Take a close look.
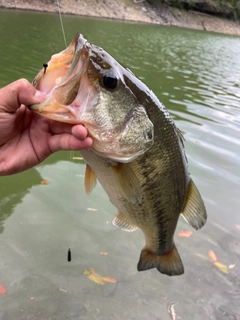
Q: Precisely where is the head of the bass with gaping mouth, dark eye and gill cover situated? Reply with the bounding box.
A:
[29,34,154,162]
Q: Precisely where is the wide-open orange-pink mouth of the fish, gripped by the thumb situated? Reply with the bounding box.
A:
[28,34,93,124]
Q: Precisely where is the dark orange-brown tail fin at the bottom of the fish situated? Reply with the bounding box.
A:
[137,244,184,276]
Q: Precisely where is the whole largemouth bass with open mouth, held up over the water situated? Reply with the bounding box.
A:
[29,34,207,276]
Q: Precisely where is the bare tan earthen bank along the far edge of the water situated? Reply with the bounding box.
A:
[0,0,240,36]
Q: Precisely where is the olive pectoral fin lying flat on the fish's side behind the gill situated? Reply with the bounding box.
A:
[112,163,142,203]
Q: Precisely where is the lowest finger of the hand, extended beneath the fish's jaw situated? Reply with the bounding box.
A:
[49,133,93,153]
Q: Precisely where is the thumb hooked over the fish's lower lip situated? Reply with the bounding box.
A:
[0,79,46,112]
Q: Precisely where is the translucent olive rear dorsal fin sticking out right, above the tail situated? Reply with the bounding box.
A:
[181,180,207,230]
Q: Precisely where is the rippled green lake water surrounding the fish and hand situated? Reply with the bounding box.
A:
[0,9,240,320]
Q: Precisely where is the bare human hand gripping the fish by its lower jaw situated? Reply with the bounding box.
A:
[0,79,92,176]
